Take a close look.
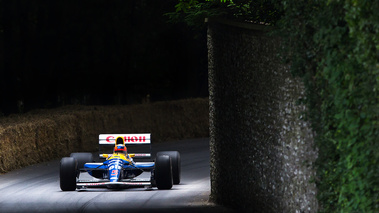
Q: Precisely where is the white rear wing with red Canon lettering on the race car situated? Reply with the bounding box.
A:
[99,133,151,159]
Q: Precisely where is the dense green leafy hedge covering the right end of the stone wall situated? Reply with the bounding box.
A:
[278,0,379,212]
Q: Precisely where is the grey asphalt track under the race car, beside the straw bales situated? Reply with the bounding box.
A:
[0,138,235,213]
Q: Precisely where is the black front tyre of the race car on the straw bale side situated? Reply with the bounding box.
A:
[59,157,78,191]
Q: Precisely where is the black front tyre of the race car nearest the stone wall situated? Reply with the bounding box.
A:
[154,155,173,189]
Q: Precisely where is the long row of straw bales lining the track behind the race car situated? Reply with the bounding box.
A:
[0,98,209,173]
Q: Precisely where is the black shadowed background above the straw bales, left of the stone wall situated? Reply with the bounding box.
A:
[0,0,208,115]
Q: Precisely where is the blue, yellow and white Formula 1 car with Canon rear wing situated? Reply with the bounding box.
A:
[60,134,181,191]
